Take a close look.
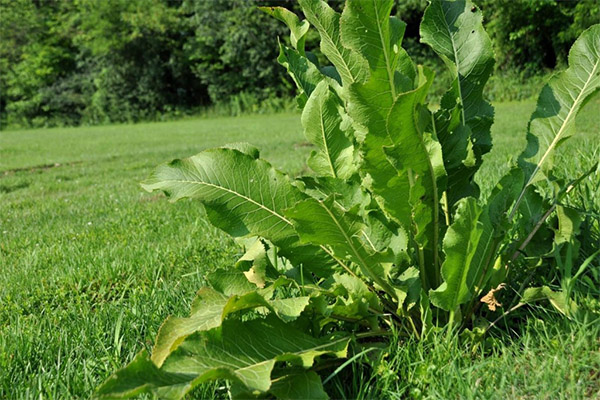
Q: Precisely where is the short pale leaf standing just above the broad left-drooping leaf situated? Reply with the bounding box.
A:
[302,81,356,178]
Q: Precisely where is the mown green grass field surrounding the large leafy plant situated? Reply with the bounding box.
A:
[0,98,600,399]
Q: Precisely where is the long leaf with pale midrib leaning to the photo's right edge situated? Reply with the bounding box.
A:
[514,24,600,210]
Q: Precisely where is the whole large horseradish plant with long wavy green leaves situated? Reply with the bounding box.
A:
[96,0,600,399]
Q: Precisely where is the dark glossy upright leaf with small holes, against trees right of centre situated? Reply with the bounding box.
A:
[421,0,494,208]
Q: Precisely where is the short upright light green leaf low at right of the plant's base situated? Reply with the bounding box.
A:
[429,197,484,311]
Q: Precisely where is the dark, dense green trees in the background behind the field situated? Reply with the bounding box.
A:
[0,0,599,126]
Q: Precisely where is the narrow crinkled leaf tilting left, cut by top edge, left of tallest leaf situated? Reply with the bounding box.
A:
[299,0,368,86]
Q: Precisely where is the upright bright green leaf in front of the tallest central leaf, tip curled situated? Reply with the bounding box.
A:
[382,67,446,288]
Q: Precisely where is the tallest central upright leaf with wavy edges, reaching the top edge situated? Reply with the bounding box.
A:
[341,0,415,229]
